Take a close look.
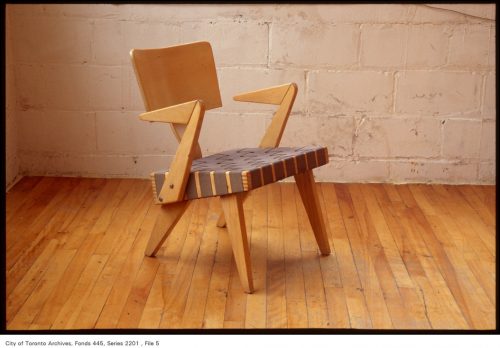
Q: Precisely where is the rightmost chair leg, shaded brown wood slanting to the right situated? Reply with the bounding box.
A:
[295,170,331,255]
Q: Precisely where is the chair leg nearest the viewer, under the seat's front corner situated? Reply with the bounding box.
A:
[221,193,254,293]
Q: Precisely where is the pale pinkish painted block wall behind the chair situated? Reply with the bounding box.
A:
[4,4,496,183]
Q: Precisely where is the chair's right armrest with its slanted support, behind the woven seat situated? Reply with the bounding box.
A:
[233,82,297,147]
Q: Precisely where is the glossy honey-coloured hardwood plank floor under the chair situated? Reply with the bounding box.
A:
[6,177,496,330]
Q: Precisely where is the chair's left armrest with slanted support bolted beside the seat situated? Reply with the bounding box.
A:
[139,100,205,204]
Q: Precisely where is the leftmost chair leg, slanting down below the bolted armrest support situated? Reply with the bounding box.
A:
[145,201,189,256]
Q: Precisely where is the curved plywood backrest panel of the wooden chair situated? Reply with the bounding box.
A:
[130,42,222,111]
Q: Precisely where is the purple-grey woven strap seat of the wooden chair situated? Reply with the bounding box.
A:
[151,146,328,200]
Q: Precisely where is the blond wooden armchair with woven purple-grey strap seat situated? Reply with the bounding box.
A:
[130,42,330,293]
